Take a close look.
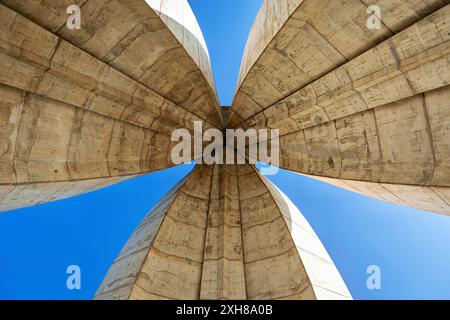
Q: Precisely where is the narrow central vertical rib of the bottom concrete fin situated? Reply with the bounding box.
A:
[200,165,246,300]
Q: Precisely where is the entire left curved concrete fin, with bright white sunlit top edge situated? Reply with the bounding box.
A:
[0,0,222,210]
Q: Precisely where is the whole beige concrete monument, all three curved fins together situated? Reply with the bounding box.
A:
[0,0,450,299]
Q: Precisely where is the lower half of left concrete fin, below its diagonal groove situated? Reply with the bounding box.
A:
[0,1,224,210]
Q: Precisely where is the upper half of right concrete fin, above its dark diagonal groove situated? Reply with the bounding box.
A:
[231,0,448,126]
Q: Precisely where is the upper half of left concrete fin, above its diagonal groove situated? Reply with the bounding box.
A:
[0,0,223,127]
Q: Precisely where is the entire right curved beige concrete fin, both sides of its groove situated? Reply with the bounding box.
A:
[230,0,450,214]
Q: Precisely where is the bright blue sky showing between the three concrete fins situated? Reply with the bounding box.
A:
[0,0,450,299]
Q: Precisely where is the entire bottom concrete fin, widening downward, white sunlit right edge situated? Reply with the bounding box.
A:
[96,165,351,300]
